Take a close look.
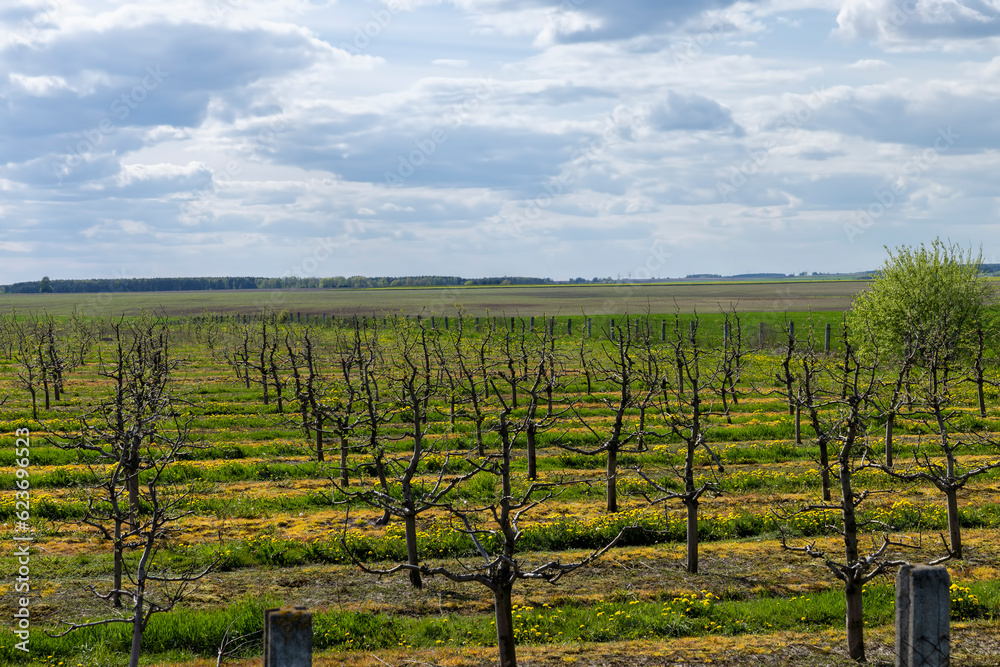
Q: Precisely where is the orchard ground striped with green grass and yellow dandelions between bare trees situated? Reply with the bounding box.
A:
[0,314,1000,667]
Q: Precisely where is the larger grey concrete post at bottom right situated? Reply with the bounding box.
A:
[896,565,951,667]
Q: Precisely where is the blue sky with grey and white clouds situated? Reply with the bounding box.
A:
[0,0,1000,283]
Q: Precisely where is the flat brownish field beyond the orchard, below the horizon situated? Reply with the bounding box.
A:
[0,280,868,317]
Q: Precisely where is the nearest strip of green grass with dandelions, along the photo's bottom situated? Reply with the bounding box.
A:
[0,581,1000,667]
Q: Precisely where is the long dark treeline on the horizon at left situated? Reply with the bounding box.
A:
[0,276,553,294]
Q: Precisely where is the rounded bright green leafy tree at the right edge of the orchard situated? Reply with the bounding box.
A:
[848,239,993,359]
